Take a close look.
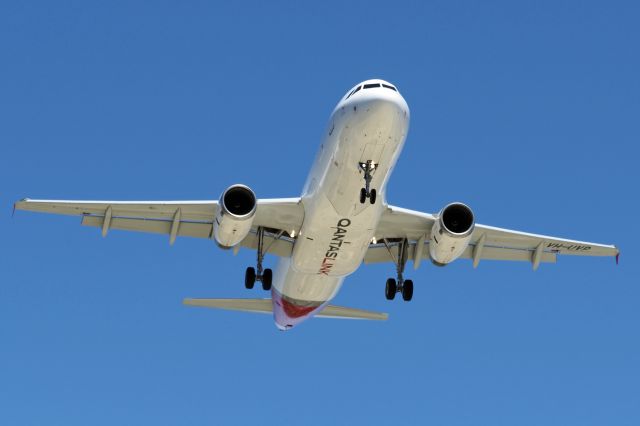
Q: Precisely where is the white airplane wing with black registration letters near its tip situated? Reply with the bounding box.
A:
[364,206,620,269]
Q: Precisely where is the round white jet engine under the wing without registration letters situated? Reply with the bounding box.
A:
[213,185,257,247]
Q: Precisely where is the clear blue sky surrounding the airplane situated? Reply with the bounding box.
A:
[0,1,640,425]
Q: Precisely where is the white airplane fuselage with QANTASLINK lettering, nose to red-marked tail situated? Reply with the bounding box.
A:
[272,80,409,330]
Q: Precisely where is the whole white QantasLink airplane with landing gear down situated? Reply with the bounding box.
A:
[14,79,619,330]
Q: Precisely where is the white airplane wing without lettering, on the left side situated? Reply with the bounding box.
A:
[14,198,304,256]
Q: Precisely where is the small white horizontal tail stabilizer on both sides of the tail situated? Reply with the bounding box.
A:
[183,299,388,320]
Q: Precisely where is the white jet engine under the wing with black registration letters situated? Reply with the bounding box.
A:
[429,203,475,266]
